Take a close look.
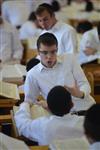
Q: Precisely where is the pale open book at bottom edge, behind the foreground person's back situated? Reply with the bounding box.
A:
[49,137,89,150]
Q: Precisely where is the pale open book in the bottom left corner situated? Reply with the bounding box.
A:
[0,132,29,150]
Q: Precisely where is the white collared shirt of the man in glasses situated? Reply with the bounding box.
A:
[24,54,93,110]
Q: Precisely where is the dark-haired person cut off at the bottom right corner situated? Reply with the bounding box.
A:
[84,104,100,150]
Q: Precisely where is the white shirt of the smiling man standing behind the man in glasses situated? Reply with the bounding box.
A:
[41,21,77,54]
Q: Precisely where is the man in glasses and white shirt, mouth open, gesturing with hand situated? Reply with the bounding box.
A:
[24,32,94,110]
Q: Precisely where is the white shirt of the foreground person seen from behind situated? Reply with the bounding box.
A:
[15,102,83,145]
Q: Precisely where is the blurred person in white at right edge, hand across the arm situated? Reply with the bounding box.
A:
[79,23,100,64]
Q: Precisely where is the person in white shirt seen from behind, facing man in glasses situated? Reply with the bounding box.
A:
[15,86,83,145]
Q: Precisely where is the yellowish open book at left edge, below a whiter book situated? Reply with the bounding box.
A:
[0,81,20,100]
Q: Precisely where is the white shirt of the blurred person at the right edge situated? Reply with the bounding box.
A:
[79,28,100,64]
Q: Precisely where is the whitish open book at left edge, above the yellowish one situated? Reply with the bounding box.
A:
[1,64,26,82]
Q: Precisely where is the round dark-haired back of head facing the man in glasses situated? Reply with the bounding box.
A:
[47,86,72,116]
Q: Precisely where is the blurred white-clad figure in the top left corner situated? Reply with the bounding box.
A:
[2,0,33,29]
